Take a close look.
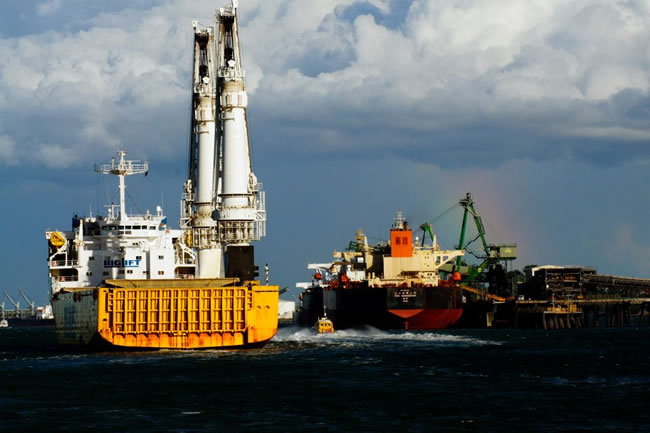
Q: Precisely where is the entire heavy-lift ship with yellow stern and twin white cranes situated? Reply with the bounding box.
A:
[46,0,278,349]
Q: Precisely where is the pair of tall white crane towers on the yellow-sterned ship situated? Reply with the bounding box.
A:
[181,0,266,278]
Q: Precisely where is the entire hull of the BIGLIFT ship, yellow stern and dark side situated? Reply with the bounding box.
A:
[52,280,278,349]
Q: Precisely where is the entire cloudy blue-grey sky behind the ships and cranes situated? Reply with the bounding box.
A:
[0,0,650,304]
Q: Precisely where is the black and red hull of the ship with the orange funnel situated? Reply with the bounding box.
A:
[299,285,463,330]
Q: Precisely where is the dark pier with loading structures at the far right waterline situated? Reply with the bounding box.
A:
[463,266,650,329]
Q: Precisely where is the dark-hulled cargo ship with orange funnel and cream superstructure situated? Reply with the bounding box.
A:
[298,212,464,330]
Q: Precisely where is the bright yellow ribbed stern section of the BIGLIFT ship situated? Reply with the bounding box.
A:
[97,280,278,349]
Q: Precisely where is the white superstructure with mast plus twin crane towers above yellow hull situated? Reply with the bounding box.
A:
[46,0,266,293]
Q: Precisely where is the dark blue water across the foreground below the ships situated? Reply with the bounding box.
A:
[0,328,650,432]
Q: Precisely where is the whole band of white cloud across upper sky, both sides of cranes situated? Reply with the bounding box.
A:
[0,0,650,169]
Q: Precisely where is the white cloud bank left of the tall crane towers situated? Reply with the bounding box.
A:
[0,7,190,167]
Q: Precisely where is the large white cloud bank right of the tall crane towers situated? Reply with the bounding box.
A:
[243,0,650,164]
